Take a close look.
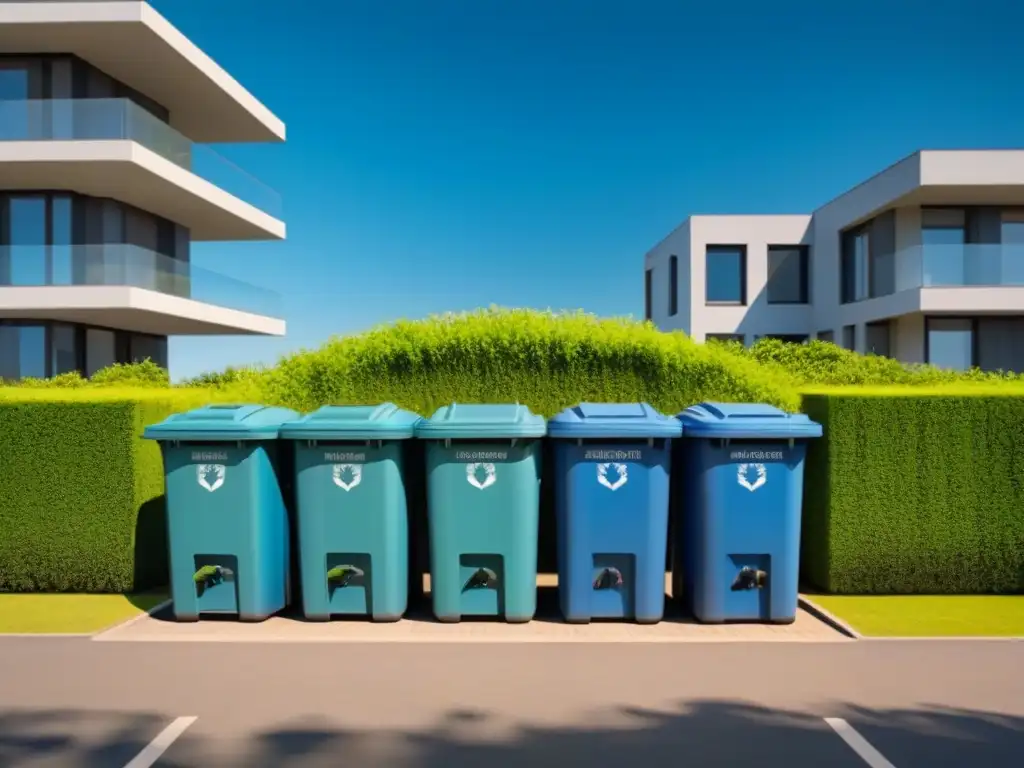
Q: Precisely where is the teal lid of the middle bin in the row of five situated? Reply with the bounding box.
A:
[416,402,548,440]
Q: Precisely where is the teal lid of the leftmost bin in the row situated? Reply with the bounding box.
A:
[142,403,299,441]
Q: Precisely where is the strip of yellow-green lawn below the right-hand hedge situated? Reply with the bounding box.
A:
[808,595,1024,637]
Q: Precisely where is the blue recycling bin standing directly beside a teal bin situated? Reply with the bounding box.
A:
[548,402,682,624]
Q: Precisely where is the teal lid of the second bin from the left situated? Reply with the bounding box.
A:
[281,402,421,440]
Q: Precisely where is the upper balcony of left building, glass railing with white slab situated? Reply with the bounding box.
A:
[0,98,284,240]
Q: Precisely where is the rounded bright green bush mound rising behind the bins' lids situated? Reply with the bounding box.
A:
[261,309,800,416]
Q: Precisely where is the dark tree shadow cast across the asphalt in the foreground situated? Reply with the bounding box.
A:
[0,704,1024,768]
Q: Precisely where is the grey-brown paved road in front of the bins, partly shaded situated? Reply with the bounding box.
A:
[0,638,1024,768]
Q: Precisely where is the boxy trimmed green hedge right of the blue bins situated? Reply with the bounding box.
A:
[801,385,1024,594]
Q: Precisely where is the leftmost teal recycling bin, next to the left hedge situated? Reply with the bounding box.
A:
[142,404,298,622]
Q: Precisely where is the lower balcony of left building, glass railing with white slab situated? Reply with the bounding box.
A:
[0,244,285,336]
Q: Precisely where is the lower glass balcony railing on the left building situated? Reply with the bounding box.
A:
[0,244,283,317]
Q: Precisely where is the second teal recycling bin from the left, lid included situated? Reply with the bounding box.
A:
[281,402,420,622]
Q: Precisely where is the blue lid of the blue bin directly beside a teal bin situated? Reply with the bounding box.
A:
[548,402,683,438]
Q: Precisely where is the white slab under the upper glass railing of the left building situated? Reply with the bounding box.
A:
[0,140,285,241]
